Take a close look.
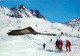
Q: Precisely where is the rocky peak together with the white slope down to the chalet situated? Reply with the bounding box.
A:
[0,5,79,36]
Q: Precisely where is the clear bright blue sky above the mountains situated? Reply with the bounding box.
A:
[0,0,80,23]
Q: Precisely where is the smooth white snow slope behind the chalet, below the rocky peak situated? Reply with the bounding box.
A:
[0,13,78,35]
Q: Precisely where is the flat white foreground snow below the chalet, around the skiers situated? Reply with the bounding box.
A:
[0,35,80,56]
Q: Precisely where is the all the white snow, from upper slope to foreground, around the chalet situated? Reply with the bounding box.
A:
[0,6,80,56]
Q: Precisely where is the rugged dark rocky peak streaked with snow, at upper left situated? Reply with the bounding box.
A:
[0,5,47,20]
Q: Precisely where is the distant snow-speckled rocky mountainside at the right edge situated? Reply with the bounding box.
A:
[64,18,80,31]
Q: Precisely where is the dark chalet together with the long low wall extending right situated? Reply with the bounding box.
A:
[7,27,56,36]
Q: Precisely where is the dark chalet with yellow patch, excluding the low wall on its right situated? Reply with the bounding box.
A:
[7,27,37,35]
